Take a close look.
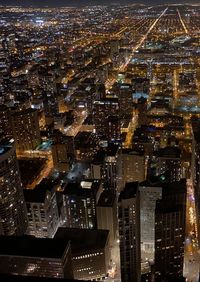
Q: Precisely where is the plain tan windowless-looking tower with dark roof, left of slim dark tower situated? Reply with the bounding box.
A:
[96,190,118,245]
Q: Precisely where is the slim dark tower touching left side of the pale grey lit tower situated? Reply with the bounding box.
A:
[118,182,141,282]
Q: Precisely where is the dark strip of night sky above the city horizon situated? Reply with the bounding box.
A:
[0,0,195,7]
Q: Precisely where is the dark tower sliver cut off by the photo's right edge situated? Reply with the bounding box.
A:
[191,118,200,242]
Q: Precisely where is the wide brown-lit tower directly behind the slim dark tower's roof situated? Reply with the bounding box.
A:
[118,149,146,193]
